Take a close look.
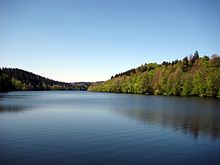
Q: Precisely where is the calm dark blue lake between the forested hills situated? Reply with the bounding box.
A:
[0,91,220,165]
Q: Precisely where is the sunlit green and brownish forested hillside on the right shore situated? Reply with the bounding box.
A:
[88,51,220,97]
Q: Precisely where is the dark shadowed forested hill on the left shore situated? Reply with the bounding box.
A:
[0,68,91,92]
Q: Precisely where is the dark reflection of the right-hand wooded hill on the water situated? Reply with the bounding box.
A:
[112,97,220,138]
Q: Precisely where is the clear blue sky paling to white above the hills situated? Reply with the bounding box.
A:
[0,0,220,82]
